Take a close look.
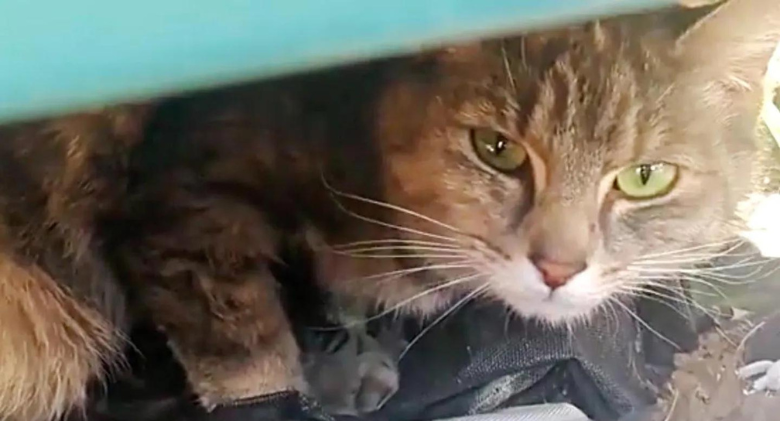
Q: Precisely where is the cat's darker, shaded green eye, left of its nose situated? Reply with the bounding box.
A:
[471,129,528,173]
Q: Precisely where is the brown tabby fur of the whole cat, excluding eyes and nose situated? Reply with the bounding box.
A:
[0,0,780,421]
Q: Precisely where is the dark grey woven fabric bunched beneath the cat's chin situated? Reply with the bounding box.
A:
[332,288,699,421]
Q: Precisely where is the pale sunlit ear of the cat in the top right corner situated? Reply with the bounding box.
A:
[676,0,780,103]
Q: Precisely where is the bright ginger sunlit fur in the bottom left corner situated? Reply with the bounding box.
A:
[0,257,121,421]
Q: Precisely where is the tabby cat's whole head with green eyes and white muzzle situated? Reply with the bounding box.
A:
[378,0,780,322]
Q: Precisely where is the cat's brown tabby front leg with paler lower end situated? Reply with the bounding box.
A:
[119,197,304,409]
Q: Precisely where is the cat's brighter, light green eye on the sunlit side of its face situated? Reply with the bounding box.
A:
[615,162,677,199]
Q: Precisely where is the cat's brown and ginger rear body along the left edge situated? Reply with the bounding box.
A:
[0,106,148,421]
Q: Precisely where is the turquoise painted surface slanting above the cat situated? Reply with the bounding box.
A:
[0,0,673,119]
